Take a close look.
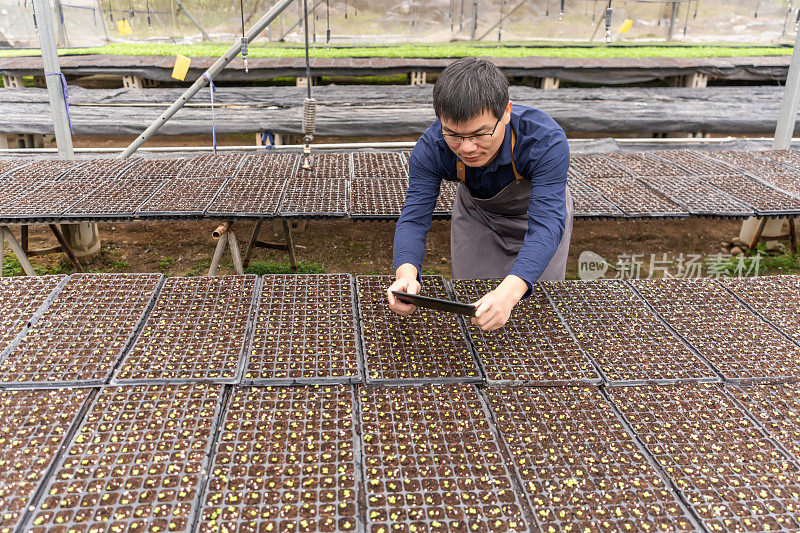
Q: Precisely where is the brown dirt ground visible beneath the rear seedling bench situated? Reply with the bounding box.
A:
[12,214,788,279]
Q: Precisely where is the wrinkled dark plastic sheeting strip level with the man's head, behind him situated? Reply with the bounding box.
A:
[0,85,800,137]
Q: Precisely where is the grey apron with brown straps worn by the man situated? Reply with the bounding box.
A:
[450,138,574,281]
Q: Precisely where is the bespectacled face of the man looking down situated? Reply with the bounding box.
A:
[442,102,511,167]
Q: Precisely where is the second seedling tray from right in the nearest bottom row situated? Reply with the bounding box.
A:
[607,384,800,531]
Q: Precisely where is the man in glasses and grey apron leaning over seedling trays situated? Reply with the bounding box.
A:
[387,58,573,331]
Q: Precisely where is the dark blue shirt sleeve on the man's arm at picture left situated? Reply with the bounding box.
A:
[393,143,442,275]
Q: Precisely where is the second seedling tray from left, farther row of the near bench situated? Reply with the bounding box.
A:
[0,274,162,387]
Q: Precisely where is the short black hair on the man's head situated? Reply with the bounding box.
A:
[433,57,508,124]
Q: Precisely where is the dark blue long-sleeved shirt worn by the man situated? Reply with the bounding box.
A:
[394,105,569,288]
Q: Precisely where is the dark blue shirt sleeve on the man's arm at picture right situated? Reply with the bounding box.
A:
[509,130,569,296]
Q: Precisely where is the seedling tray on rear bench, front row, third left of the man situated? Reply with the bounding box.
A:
[207,177,287,218]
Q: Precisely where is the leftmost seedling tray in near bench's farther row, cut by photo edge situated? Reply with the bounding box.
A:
[0,276,67,356]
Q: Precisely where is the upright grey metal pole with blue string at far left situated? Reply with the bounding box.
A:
[33,0,75,159]
